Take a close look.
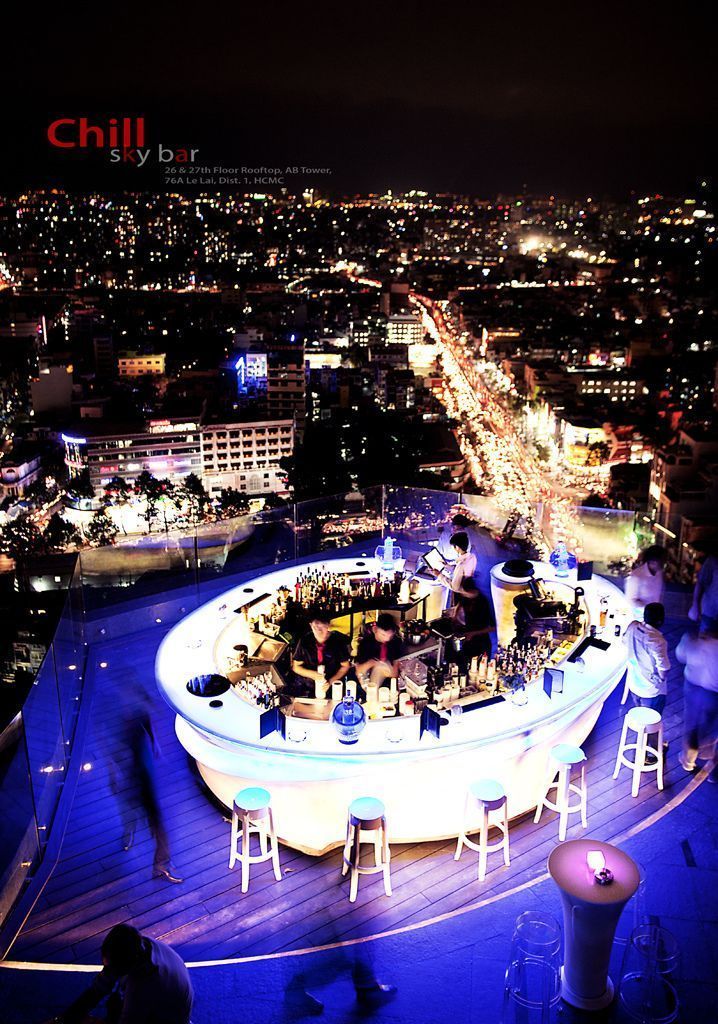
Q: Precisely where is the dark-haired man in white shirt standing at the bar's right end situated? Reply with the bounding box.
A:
[624,602,671,715]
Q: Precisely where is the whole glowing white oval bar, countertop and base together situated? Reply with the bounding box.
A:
[156,558,628,855]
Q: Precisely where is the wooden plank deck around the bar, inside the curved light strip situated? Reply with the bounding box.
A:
[4,622,689,964]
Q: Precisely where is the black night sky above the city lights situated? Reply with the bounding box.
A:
[0,0,716,195]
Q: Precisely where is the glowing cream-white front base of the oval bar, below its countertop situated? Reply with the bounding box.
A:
[175,703,600,856]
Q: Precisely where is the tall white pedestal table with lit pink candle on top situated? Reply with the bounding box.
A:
[548,839,639,1010]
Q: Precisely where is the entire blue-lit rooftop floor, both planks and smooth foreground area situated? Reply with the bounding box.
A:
[0,606,718,1024]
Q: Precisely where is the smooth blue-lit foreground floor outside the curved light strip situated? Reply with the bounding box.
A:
[0,783,718,1024]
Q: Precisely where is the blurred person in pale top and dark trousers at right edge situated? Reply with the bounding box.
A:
[676,630,718,782]
